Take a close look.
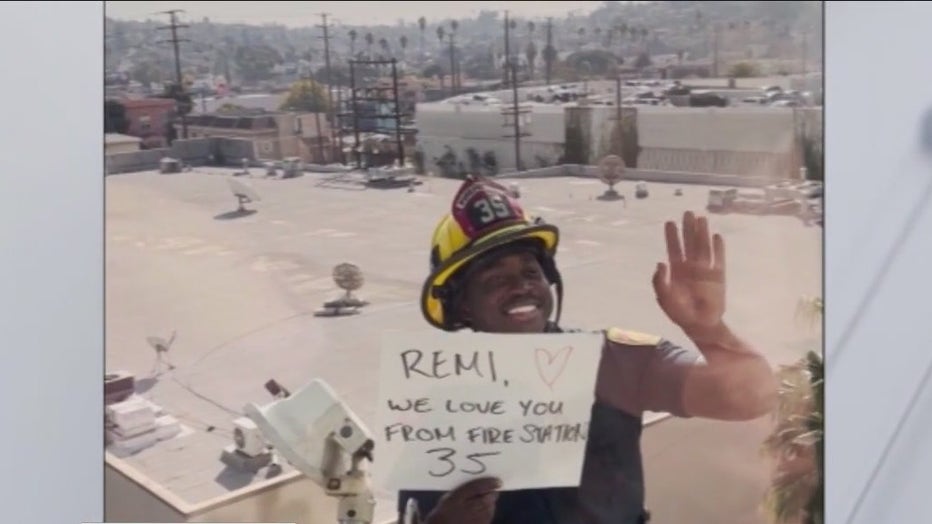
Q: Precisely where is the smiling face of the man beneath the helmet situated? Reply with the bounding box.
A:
[460,252,553,333]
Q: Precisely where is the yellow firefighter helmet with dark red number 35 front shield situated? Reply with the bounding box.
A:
[421,176,563,331]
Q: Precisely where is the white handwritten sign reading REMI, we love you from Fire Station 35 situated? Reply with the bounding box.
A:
[373,332,603,490]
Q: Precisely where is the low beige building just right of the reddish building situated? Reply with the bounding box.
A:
[176,109,336,163]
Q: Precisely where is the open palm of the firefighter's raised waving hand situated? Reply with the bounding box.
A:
[653,212,725,331]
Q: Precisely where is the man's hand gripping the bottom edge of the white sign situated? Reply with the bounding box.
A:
[424,478,502,524]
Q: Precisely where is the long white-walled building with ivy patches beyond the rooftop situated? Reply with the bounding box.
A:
[417,96,821,179]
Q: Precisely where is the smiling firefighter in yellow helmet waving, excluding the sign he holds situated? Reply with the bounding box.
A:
[398,177,777,524]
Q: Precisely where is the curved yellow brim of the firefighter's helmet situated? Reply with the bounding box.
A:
[421,224,560,329]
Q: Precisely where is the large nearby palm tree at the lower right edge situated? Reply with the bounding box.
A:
[763,297,824,524]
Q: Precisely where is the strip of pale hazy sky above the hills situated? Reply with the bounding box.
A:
[105,1,602,27]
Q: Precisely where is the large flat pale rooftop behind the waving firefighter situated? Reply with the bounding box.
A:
[106,167,822,522]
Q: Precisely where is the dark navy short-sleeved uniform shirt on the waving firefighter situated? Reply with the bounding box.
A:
[398,327,700,524]
